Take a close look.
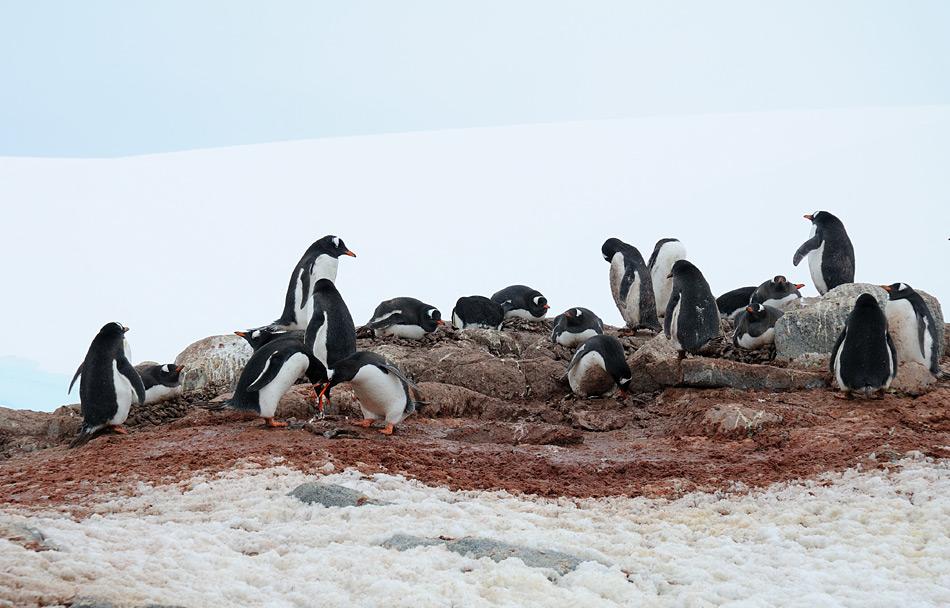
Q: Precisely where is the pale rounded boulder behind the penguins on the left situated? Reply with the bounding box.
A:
[175,336,253,392]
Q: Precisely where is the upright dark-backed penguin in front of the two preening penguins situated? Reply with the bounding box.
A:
[663,260,720,357]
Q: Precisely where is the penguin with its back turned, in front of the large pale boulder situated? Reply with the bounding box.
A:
[830,293,897,398]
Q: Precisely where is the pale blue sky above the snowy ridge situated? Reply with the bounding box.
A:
[0,0,950,156]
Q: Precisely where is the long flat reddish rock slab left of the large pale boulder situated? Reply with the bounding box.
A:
[681,357,828,391]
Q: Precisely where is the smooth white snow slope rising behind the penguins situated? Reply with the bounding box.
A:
[0,106,950,402]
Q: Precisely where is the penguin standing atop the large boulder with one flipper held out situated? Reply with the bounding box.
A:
[792,211,854,295]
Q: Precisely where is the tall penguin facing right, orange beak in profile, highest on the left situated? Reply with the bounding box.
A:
[271,234,356,330]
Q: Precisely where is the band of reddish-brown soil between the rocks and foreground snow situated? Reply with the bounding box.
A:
[0,384,950,505]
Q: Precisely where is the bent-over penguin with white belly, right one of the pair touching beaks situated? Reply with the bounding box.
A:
[324,351,423,435]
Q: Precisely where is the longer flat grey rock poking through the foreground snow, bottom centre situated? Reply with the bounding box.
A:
[382,534,587,576]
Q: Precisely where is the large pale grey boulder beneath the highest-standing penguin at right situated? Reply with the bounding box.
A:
[775,283,944,368]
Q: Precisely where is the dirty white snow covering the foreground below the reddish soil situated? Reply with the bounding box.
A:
[0,460,950,608]
